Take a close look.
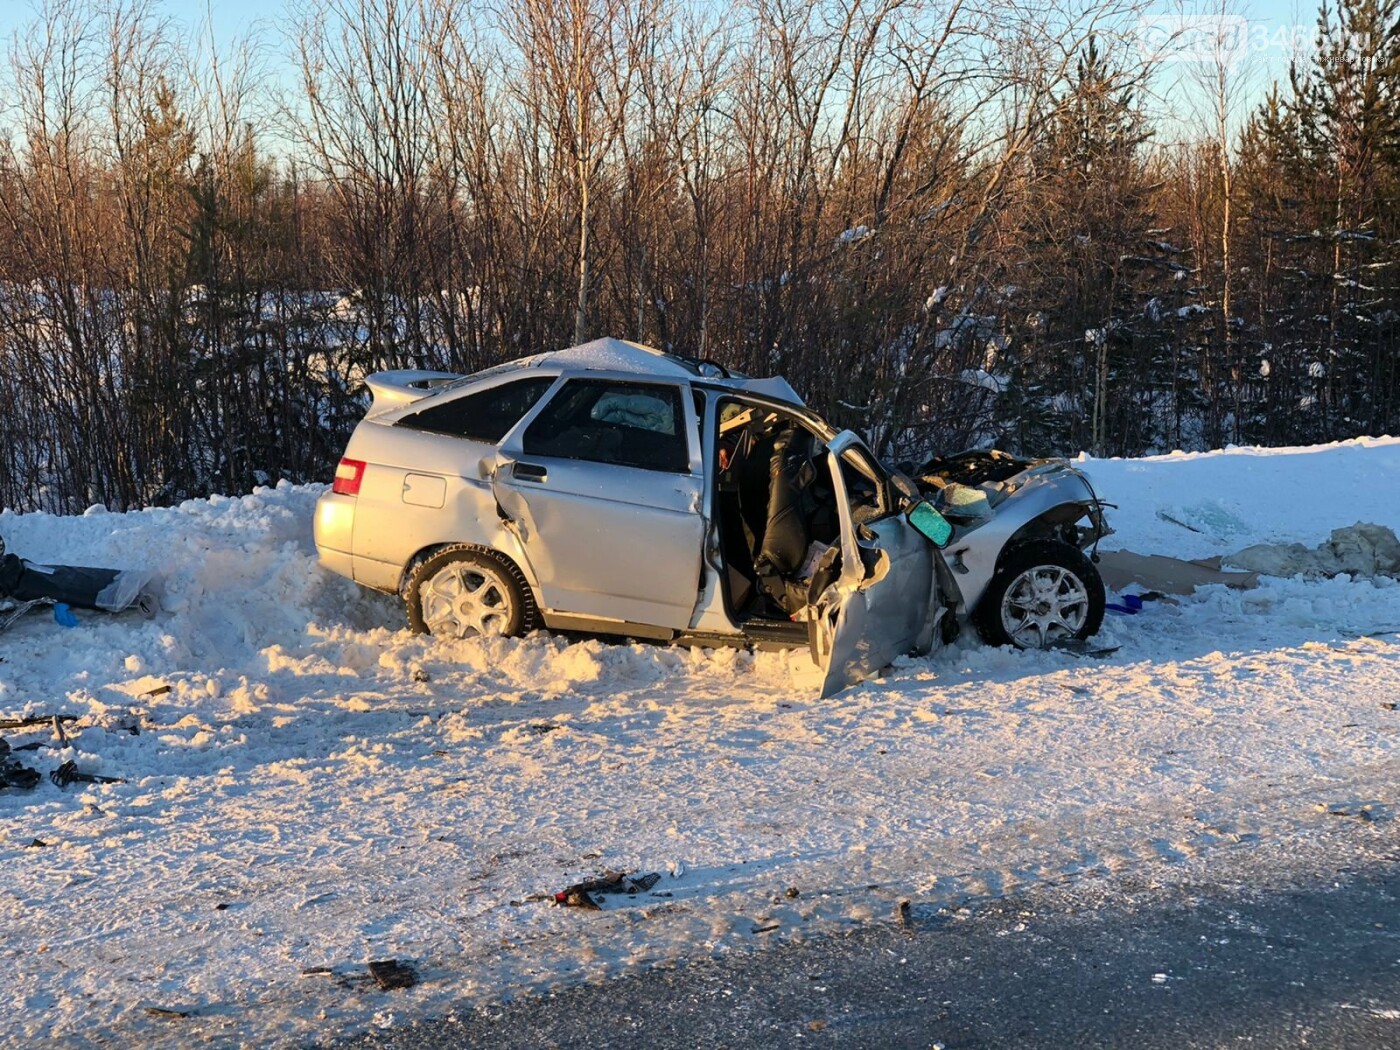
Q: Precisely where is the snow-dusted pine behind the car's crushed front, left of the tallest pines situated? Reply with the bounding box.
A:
[1012,39,1169,452]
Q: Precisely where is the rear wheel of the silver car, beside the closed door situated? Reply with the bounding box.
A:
[403,545,539,638]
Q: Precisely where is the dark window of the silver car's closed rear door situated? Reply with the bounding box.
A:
[524,379,690,473]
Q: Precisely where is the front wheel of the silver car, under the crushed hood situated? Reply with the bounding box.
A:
[974,540,1105,650]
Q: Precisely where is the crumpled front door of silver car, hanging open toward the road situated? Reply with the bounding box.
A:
[806,430,939,697]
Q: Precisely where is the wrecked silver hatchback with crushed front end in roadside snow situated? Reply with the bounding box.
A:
[315,339,1103,694]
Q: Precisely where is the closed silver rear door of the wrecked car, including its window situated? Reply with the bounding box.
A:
[493,378,704,630]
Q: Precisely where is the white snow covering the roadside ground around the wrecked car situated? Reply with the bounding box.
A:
[0,438,1400,1046]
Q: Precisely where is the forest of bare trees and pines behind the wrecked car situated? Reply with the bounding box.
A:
[0,0,1400,511]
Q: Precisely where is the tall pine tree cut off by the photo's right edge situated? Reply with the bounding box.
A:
[1242,0,1400,440]
